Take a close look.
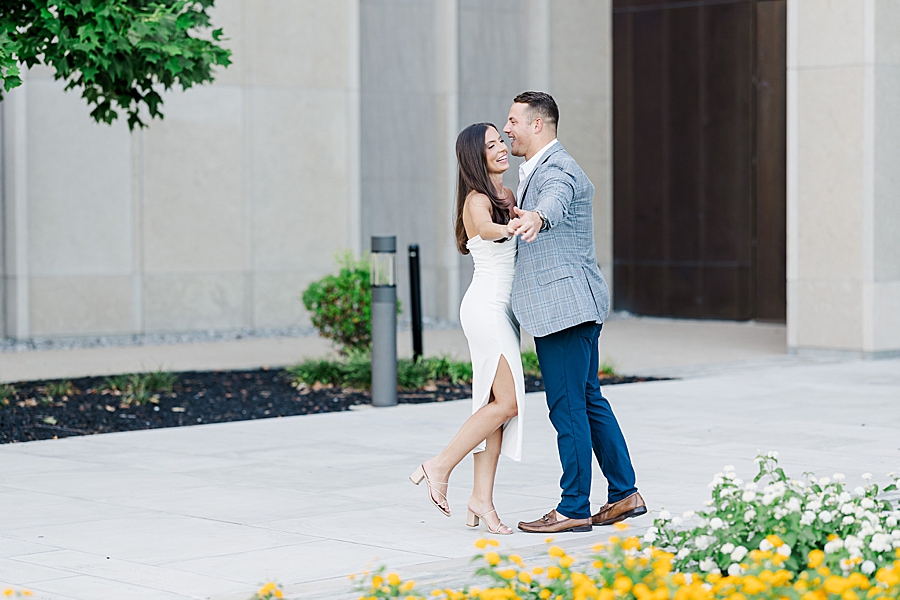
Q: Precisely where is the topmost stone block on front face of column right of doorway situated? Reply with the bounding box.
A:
[800,0,866,67]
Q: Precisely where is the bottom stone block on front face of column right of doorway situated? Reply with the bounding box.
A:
[793,281,863,351]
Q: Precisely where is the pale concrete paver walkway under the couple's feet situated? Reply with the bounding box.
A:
[0,358,900,600]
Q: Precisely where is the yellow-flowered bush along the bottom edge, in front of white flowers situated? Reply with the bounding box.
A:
[348,525,900,600]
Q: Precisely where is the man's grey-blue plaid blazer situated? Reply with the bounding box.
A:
[512,143,609,337]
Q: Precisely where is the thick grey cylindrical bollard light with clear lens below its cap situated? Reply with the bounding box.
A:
[369,235,397,406]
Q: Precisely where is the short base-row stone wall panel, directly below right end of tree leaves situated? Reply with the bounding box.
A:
[143,273,250,333]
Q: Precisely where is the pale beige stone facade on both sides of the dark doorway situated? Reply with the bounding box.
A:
[0,0,900,355]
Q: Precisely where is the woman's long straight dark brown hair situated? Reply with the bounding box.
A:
[456,123,512,254]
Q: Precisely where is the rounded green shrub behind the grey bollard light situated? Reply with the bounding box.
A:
[303,252,372,351]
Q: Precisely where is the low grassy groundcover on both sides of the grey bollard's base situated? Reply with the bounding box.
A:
[288,351,472,390]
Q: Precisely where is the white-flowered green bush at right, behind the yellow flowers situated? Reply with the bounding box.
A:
[643,452,900,578]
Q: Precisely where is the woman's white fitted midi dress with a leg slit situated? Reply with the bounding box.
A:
[459,235,525,460]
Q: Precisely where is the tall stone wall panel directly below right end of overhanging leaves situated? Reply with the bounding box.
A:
[143,86,248,273]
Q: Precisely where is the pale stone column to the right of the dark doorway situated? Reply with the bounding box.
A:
[787,0,900,357]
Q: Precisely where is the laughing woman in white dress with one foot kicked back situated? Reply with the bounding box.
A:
[410,123,525,535]
